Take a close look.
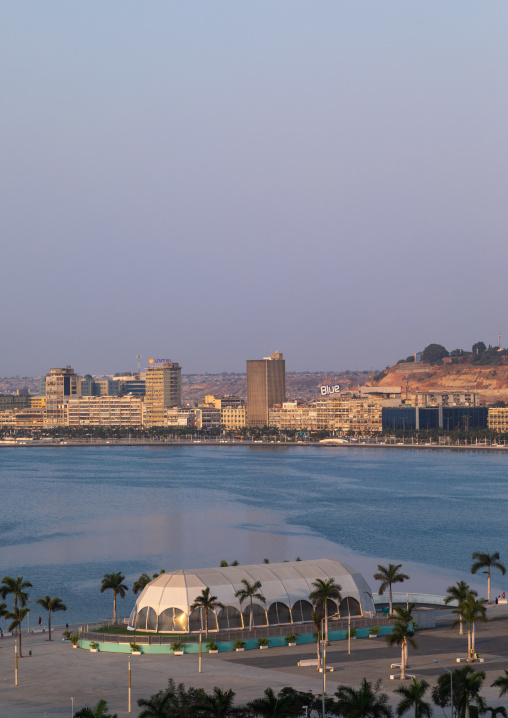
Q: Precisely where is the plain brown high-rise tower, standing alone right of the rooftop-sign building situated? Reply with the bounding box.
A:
[247,352,286,426]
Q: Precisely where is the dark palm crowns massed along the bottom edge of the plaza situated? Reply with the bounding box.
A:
[75,666,508,718]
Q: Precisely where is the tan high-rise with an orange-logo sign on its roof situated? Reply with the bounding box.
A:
[144,362,182,426]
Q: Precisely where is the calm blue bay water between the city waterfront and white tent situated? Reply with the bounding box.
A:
[0,446,508,621]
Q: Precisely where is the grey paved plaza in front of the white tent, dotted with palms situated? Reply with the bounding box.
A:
[0,607,508,718]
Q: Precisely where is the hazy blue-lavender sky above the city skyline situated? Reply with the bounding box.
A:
[0,0,508,376]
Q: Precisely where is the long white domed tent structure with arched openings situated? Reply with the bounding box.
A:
[129,559,375,633]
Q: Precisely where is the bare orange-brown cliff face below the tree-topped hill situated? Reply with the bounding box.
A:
[369,362,508,404]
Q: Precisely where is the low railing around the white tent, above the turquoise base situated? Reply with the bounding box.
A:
[79,616,393,646]
